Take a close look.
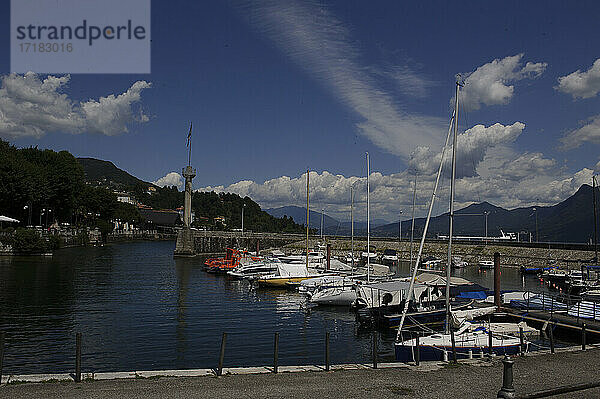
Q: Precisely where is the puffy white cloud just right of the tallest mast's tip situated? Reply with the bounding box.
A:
[458,54,548,110]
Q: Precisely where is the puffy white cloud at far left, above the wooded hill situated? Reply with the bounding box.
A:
[0,72,151,138]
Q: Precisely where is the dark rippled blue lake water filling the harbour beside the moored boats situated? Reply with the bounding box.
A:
[0,242,543,374]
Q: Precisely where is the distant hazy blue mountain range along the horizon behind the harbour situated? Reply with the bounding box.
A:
[77,158,600,243]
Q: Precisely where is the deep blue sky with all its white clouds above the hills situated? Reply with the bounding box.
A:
[0,0,600,220]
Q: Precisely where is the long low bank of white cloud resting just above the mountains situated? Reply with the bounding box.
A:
[199,145,600,221]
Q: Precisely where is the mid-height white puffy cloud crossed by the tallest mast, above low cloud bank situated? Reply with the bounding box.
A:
[409,122,525,177]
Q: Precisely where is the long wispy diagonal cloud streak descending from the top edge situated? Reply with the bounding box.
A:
[233,1,446,159]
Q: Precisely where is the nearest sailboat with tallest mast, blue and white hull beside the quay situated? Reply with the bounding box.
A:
[394,75,521,361]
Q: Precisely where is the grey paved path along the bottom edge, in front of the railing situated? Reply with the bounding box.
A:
[0,349,600,399]
